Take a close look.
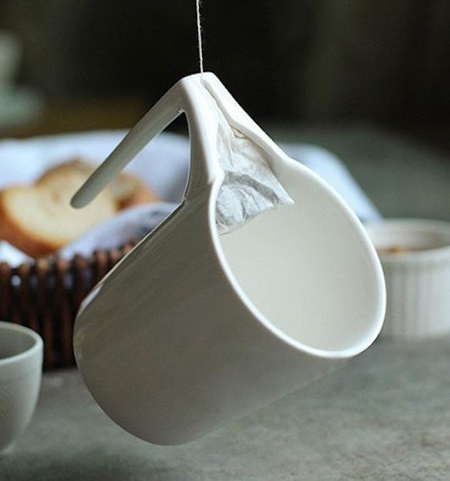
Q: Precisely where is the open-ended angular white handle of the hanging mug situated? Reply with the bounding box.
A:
[71,74,223,208]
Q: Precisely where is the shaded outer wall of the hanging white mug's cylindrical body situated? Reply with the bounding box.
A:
[74,189,310,444]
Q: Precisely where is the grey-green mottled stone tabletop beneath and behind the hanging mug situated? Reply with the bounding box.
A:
[0,127,450,481]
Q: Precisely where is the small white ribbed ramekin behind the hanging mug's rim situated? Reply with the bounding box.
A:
[366,219,450,340]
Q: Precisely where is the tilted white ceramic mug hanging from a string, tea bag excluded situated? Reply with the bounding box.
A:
[74,74,384,444]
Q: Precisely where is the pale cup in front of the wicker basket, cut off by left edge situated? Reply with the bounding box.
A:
[0,322,43,453]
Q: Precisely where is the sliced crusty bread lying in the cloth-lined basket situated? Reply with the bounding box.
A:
[0,159,159,257]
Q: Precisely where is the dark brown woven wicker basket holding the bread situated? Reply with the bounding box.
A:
[0,241,136,369]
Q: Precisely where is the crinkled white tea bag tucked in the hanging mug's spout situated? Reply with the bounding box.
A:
[216,110,294,234]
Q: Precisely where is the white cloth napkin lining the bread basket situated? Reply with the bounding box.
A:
[0,131,380,265]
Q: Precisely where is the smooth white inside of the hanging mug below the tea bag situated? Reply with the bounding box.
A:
[218,161,384,355]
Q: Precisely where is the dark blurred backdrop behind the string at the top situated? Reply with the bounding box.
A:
[0,0,450,149]
